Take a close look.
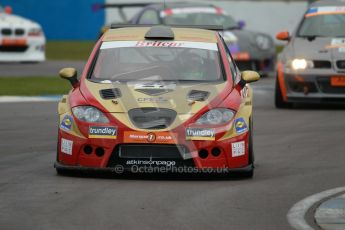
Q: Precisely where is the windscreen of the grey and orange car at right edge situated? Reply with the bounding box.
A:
[297,7,345,37]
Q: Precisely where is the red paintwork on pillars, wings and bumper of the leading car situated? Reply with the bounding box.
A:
[58,31,249,168]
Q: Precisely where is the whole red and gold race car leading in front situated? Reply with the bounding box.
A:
[55,25,259,176]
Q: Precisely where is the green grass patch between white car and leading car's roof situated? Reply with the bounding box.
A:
[46,41,95,60]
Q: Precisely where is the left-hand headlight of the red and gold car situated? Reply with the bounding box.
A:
[72,106,109,123]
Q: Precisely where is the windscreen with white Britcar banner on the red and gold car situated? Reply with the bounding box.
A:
[89,41,225,82]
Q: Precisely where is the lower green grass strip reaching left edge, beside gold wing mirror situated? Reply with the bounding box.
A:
[0,77,71,96]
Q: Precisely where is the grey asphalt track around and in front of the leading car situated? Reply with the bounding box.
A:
[0,78,345,230]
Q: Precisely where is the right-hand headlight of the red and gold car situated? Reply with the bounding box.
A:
[196,108,235,125]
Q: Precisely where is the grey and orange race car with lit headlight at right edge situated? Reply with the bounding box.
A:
[275,0,345,108]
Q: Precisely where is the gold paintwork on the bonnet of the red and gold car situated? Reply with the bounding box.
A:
[85,81,227,131]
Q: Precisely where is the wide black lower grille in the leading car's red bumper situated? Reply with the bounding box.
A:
[107,144,195,167]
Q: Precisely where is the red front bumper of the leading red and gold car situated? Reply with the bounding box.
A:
[57,126,249,170]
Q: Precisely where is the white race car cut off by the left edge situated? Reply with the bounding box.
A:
[0,6,46,62]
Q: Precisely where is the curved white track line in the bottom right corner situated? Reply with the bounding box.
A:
[287,187,345,230]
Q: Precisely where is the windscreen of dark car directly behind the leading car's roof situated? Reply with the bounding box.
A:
[161,7,237,29]
